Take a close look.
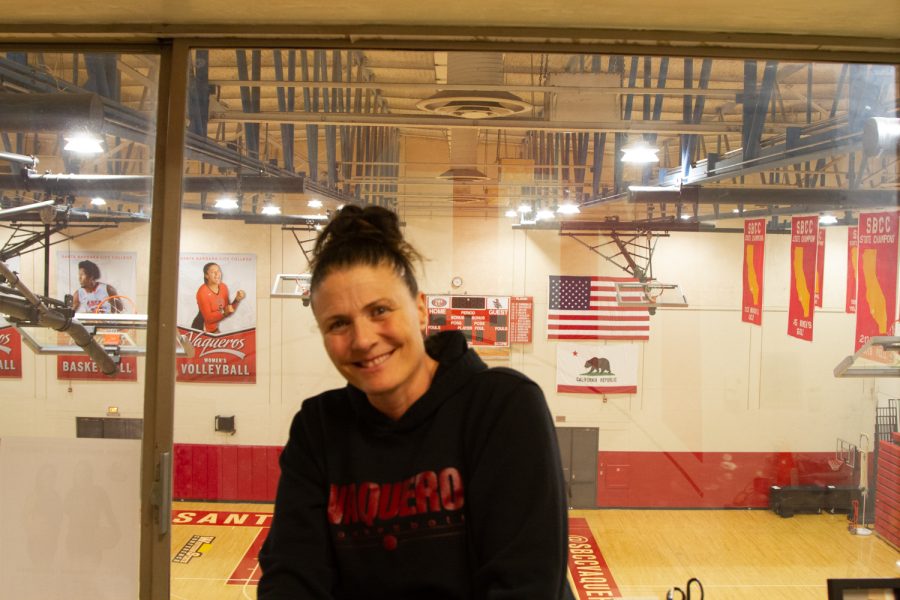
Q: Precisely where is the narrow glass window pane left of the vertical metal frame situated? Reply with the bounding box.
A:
[0,49,160,598]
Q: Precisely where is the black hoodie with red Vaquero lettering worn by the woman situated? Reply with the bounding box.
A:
[258,331,567,600]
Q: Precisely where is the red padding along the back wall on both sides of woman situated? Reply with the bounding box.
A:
[174,444,854,508]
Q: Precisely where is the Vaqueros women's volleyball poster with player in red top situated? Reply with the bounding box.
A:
[175,252,256,383]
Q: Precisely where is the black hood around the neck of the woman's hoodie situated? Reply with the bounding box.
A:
[347,331,487,435]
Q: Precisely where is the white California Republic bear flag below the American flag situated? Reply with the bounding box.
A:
[556,342,639,394]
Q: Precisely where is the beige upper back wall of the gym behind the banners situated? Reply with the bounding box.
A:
[0,211,898,451]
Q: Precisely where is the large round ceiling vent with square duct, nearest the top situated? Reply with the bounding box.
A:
[416,52,531,120]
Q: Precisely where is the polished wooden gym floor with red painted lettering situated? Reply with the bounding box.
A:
[171,502,900,600]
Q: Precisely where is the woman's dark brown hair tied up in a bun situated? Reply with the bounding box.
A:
[310,204,422,296]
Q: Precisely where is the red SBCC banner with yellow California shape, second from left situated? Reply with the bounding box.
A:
[788,215,819,342]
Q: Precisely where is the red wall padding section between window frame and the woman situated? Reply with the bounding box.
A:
[173,444,281,502]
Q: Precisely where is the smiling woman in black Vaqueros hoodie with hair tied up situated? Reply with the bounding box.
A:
[258,206,567,600]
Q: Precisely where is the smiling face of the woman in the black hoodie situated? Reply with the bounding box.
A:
[312,265,431,408]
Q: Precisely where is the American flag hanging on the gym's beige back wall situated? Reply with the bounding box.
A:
[547,275,650,340]
